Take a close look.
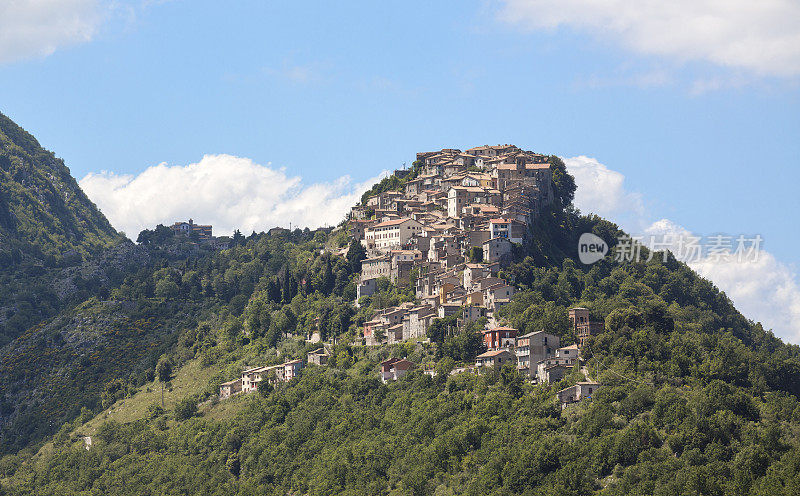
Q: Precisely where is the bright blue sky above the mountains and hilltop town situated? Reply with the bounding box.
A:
[0,0,800,335]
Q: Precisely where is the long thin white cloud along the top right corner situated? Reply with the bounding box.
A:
[500,0,800,76]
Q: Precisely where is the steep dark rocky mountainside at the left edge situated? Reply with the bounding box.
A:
[0,114,123,346]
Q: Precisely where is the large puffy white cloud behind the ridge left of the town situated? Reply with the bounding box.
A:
[80,155,386,239]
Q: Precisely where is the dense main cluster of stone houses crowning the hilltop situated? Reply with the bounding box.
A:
[349,145,553,345]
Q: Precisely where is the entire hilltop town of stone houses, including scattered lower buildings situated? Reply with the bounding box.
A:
[220,145,603,406]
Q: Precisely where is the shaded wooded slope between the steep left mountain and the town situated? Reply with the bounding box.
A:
[0,230,355,452]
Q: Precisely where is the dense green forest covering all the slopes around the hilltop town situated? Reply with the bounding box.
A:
[0,113,800,496]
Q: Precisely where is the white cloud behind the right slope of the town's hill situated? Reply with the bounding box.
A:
[564,156,800,343]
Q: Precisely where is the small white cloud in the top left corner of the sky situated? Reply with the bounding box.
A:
[0,0,104,63]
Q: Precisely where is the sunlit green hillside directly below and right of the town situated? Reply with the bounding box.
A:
[3,201,800,495]
